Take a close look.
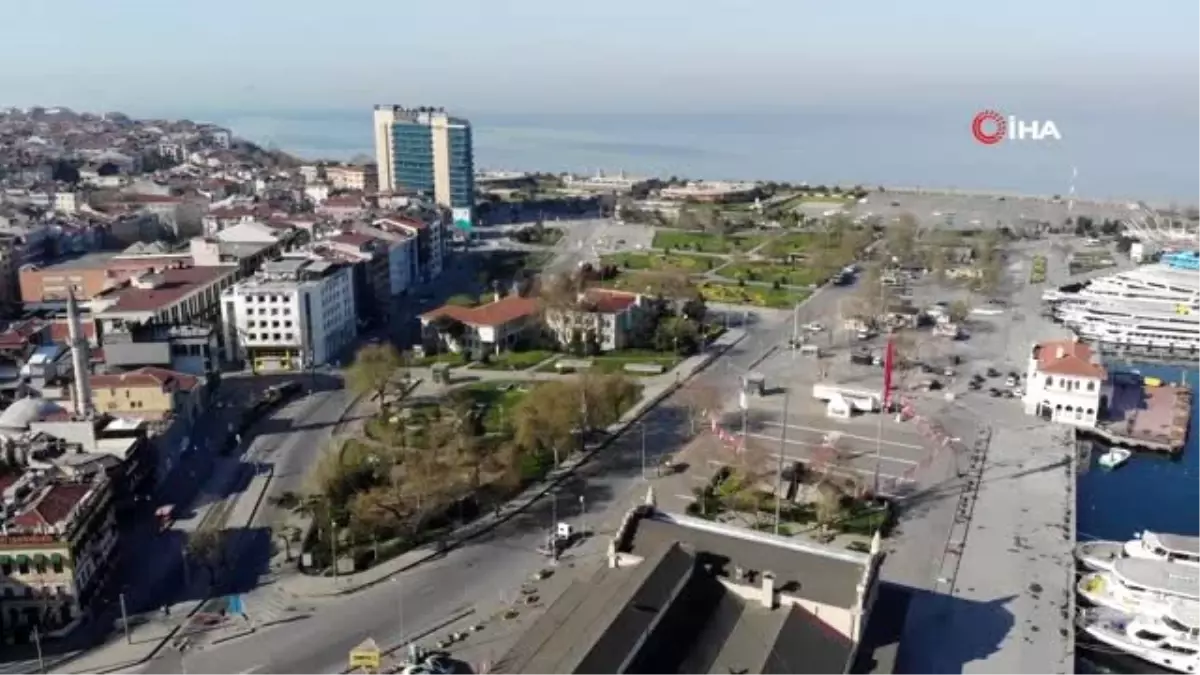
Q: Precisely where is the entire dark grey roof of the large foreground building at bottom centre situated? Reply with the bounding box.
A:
[492,513,884,675]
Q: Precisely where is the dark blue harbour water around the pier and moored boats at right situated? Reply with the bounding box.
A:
[1075,363,1200,675]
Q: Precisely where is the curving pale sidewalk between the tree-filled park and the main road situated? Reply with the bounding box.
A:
[278,329,745,598]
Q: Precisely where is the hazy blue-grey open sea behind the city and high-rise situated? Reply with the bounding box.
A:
[187,108,1200,207]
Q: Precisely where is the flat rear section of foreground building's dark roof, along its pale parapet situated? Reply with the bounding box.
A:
[629,514,869,608]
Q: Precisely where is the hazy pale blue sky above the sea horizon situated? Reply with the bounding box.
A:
[0,0,1200,116]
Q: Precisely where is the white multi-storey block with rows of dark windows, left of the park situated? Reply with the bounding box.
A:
[221,258,358,371]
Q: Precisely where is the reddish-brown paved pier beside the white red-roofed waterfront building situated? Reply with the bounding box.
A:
[1078,378,1192,454]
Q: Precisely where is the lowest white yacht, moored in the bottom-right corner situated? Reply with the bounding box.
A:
[1079,607,1200,673]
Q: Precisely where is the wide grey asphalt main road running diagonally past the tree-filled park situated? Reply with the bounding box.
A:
[145,281,846,675]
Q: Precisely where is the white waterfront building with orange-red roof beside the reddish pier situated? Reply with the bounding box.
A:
[1022,339,1112,426]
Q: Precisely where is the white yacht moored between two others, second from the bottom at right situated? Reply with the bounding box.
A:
[1075,557,1200,616]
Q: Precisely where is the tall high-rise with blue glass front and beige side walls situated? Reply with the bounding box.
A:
[374,106,475,222]
